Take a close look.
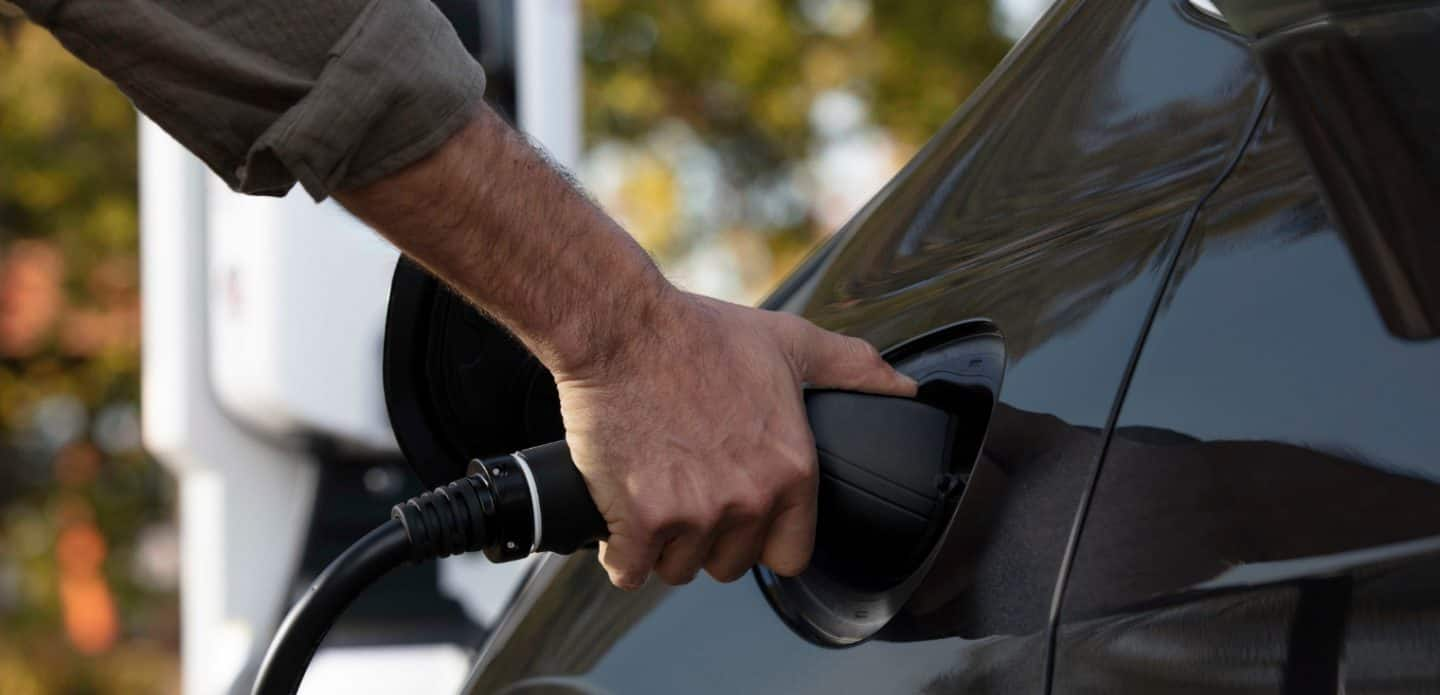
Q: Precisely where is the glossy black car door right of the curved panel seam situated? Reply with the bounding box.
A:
[1053,9,1440,694]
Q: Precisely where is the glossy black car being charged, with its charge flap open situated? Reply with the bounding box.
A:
[387,0,1440,694]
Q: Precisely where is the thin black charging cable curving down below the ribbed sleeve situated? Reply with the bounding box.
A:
[253,519,410,695]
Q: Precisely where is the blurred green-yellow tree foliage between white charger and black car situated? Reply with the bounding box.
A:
[583,0,1009,296]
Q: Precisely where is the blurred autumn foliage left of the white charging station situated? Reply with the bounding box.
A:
[0,1,177,695]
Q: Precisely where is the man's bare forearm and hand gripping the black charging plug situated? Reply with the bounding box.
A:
[336,108,916,589]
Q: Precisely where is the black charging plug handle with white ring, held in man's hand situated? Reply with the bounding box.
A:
[486,390,963,586]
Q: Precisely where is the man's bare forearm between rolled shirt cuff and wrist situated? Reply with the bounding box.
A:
[336,106,672,373]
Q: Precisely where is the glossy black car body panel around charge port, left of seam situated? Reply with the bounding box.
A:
[469,0,1263,694]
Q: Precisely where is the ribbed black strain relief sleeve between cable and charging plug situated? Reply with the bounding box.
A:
[390,475,495,563]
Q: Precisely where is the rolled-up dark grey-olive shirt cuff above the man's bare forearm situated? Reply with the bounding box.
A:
[235,0,485,200]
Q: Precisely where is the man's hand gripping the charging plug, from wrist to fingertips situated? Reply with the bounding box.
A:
[556,291,916,589]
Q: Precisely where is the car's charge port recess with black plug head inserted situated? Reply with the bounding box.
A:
[756,321,1005,646]
